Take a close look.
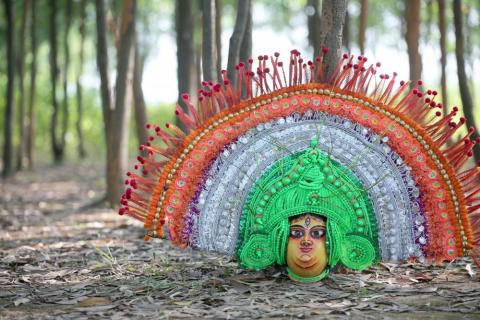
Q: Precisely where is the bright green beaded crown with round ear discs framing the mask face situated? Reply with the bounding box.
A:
[237,139,379,276]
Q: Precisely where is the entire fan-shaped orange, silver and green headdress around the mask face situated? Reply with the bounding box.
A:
[120,50,480,276]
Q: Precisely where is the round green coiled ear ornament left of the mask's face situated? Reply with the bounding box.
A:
[240,234,275,270]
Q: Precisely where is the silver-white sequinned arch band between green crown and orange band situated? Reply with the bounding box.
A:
[186,111,426,260]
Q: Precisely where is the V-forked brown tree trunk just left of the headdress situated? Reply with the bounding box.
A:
[96,0,136,206]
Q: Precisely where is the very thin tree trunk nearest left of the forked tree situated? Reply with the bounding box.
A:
[76,0,87,159]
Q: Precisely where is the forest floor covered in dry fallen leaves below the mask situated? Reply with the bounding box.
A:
[0,163,480,319]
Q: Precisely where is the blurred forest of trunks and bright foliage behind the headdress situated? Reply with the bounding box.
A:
[0,0,480,204]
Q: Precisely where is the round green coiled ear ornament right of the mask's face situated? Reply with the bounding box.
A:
[340,235,375,270]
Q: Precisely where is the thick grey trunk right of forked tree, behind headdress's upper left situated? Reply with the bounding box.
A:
[175,0,197,116]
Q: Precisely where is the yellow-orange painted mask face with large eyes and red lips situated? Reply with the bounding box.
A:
[287,213,328,277]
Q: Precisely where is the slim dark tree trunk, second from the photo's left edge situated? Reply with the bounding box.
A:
[26,0,37,170]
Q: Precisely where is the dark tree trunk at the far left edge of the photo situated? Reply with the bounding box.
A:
[2,0,15,178]
